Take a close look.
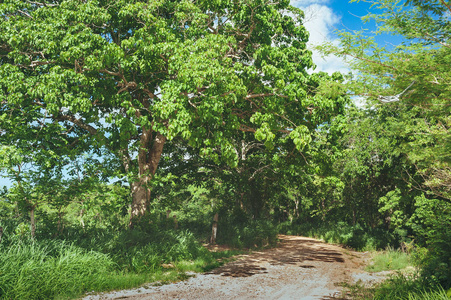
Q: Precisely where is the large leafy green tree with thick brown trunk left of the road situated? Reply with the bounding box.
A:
[0,0,343,224]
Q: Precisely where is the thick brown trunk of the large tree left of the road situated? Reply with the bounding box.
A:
[129,129,166,227]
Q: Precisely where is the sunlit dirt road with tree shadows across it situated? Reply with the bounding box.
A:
[84,235,392,300]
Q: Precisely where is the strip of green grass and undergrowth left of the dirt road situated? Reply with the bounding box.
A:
[0,228,240,299]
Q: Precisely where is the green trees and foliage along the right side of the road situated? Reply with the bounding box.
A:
[322,0,451,286]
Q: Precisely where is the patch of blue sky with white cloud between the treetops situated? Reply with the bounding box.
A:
[0,0,396,188]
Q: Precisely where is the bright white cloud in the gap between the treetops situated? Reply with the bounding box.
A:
[291,0,349,73]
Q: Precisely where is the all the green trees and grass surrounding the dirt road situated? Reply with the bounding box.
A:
[0,0,451,299]
